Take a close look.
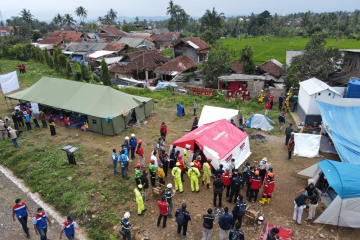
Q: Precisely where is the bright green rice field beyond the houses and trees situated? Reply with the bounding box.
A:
[220,38,360,64]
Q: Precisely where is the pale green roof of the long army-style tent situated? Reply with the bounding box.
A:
[6,77,152,118]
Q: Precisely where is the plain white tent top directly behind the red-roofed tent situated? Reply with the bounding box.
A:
[198,105,240,127]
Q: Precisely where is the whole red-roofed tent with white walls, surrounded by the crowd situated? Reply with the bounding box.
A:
[172,119,251,169]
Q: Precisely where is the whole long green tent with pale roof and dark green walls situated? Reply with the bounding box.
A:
[6,77,152,135]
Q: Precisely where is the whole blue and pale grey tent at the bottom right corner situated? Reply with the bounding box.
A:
[298,159,360,228]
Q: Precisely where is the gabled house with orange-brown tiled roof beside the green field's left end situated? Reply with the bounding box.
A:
[174,37,211,63]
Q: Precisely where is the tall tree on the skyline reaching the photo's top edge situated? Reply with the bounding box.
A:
[166,1,190,32]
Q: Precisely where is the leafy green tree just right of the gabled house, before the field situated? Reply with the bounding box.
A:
[200,43,233,89]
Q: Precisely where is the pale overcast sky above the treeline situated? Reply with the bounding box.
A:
[0,0,360,21]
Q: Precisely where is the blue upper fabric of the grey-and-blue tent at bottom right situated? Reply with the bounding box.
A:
[317,159,360,199]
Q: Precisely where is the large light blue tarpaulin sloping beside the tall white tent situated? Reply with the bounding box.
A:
[316,99,360,165]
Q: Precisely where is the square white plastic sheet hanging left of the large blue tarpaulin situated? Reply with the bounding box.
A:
[294,133,321,158]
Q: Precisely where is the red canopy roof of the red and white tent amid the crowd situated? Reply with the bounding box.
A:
[172,119,248,159]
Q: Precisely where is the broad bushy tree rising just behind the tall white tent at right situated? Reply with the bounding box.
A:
[284,33,343,87]
